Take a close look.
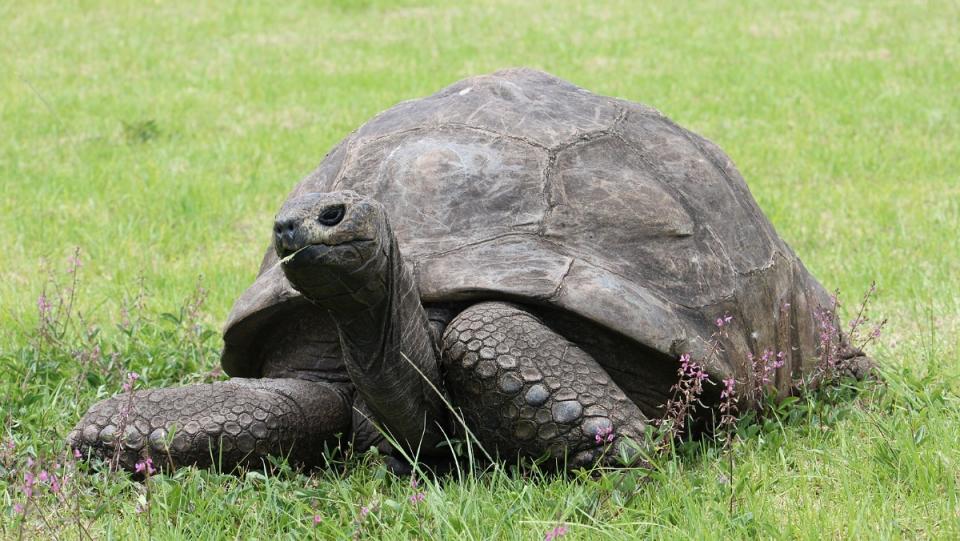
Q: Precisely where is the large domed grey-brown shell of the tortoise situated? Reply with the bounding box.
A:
[222,69,829,396]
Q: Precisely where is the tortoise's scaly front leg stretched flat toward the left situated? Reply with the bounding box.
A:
[68,378,352,471]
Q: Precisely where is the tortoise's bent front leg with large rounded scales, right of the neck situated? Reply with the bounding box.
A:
[442,302,646,468]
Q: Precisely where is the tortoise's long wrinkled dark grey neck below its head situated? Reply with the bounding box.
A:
[301,224,446,452]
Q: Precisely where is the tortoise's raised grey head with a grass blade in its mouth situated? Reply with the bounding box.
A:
[273,191,396,311]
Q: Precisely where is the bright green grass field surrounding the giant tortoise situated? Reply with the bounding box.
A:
[0,0,960,539]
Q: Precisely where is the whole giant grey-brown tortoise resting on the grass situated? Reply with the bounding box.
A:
[70,69,864,468]
